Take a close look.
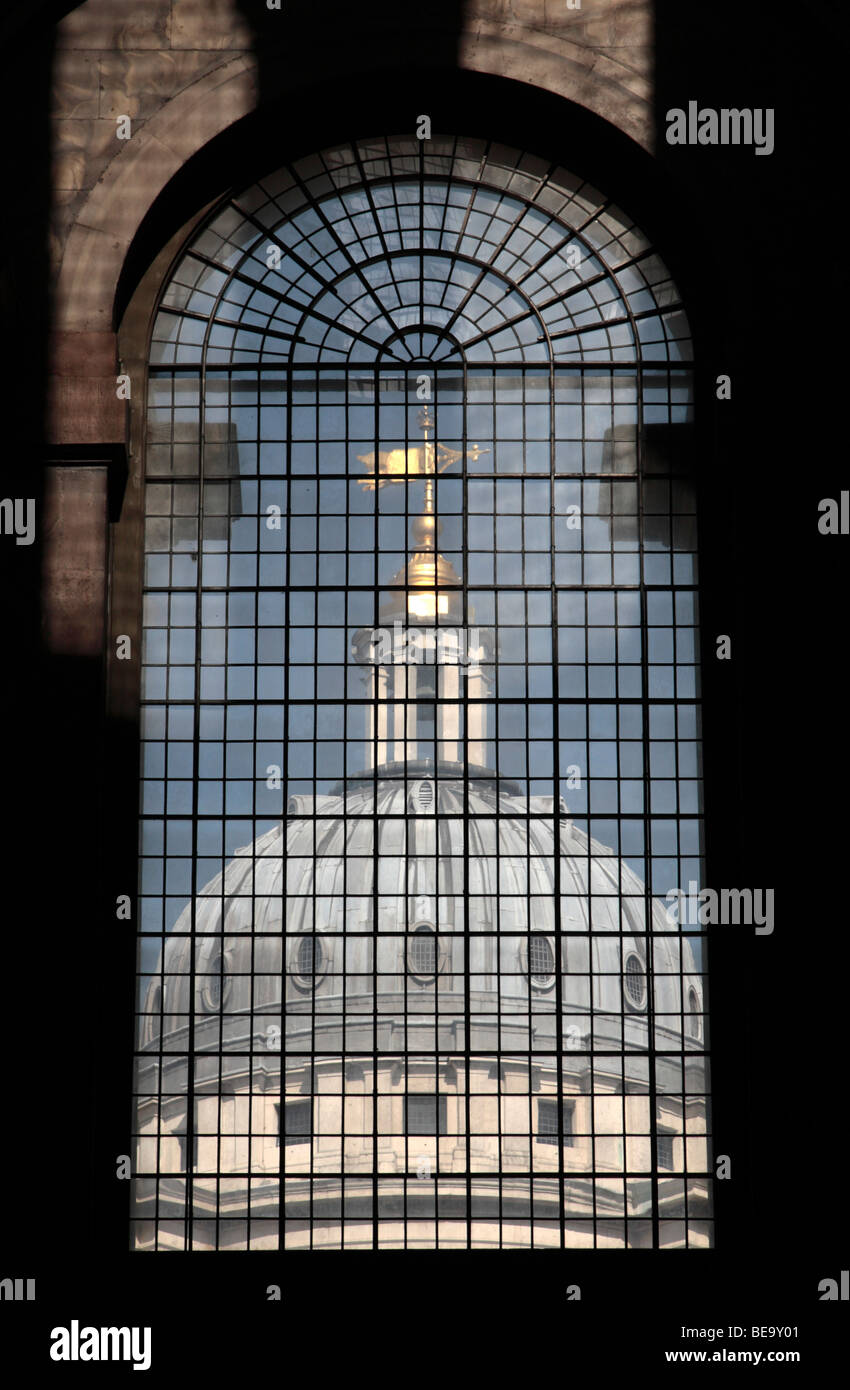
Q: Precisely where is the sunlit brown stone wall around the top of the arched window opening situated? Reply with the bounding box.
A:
[49,0,653,443]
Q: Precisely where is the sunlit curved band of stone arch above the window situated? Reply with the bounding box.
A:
[54,0,653,347]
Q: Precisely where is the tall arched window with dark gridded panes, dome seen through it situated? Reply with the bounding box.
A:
[136,138,711,1248]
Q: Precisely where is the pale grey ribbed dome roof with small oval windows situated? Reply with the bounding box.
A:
[147,765,703,1048]
